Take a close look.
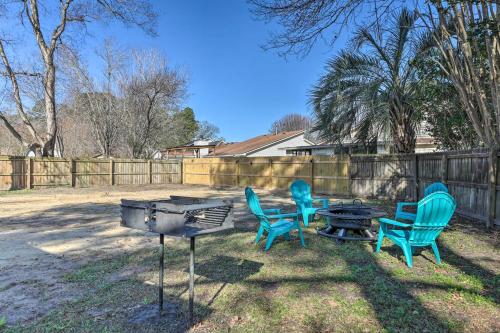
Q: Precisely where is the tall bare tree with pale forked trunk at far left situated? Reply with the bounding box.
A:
[0,0,156,156]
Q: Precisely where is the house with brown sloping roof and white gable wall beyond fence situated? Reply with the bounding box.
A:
[209,131,313,157]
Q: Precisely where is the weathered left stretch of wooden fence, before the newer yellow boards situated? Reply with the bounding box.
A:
[0,156,182,190]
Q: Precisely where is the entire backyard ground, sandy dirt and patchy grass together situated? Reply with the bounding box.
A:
[0,185,500,332]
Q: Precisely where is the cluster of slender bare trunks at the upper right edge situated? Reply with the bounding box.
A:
[422,0,500,147]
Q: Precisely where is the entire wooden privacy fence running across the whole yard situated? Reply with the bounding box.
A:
[0,150,500,226]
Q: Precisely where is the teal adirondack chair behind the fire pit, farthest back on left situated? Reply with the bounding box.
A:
[290,179,329,227]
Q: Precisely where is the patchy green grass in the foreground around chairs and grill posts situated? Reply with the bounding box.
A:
[4,219,500,332]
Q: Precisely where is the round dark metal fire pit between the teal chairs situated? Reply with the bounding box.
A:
[317,199,386,243]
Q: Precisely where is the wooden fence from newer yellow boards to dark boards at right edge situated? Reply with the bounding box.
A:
[182,150,500,226]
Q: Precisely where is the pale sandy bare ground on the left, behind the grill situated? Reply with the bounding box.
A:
[0,185,286,324]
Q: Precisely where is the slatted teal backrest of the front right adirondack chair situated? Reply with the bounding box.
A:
[409,191,457,245]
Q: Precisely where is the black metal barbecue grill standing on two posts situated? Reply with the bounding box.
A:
[121,196,234,321]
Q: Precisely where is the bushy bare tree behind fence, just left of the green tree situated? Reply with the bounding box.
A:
[122,50,186,158]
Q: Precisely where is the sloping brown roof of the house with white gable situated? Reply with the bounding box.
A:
[210,131,304,156]
